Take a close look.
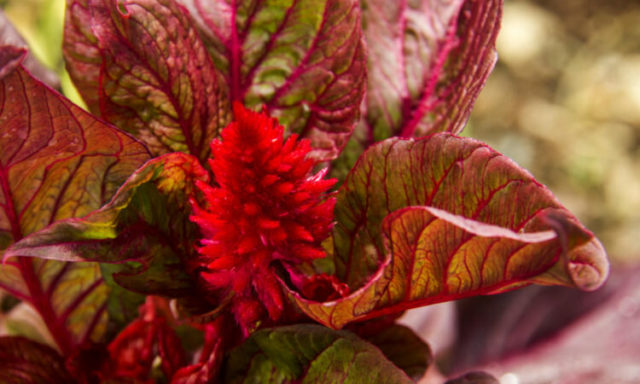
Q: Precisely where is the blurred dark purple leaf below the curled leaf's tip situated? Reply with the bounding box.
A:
[449,280,619,372]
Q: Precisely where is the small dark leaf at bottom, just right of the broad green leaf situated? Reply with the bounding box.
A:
[366,324,433,382]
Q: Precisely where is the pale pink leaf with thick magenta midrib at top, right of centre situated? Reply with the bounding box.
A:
[361,0,502,141]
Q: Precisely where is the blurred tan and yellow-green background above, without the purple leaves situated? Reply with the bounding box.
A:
[0,0,640,264]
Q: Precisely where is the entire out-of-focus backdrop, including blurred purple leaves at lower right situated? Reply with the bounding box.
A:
[0,0,640,384]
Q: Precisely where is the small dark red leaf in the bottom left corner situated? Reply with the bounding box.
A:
[0,337,75,384]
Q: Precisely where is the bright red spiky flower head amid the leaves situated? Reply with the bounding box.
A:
[191,103,335,332]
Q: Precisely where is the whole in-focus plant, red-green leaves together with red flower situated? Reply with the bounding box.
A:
[0,0,608,383]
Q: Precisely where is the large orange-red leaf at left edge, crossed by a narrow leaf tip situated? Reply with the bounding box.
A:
[0,47,149,353]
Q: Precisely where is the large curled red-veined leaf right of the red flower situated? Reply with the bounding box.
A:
[284,134,608,328]
